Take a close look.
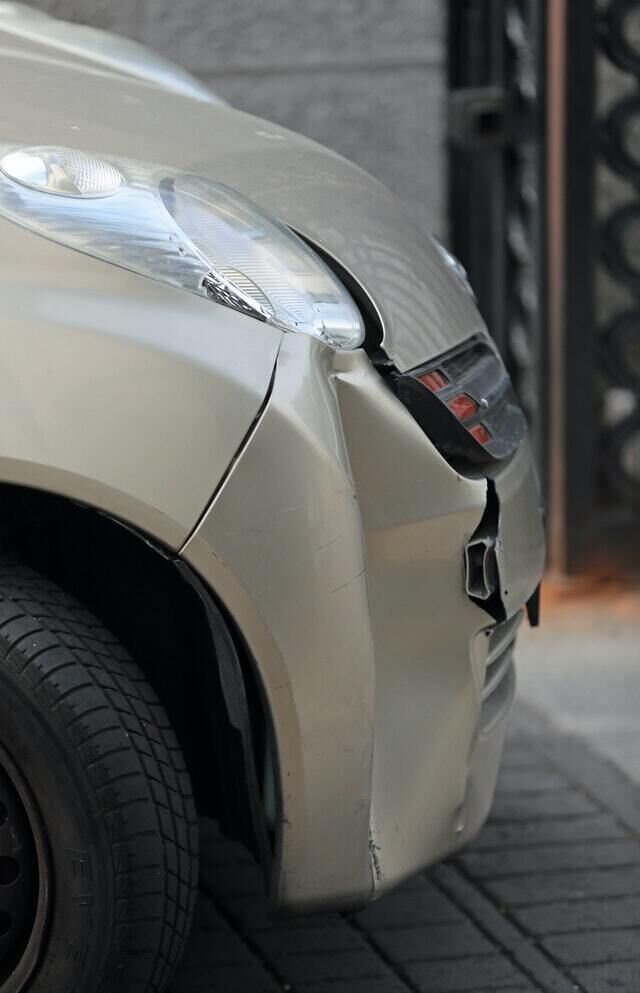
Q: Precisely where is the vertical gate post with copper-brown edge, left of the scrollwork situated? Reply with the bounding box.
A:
[547,0,595,572]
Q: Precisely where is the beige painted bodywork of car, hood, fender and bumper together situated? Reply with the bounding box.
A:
[0,11,541,909]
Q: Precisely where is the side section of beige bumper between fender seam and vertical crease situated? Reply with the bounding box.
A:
[184,335,375,909]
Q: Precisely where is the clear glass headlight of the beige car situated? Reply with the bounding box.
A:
[0,147,364,348]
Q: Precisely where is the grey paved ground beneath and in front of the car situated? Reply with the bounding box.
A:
[172,588,640,993]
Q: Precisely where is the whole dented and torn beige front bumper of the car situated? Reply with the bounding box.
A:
[183,335,544,910]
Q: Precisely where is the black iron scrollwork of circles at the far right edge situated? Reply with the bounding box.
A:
[597,0,640,515]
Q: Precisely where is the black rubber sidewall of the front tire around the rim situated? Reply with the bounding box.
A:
[0,659,117,993]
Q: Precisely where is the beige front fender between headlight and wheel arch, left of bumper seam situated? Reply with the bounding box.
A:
[0,220,282,549]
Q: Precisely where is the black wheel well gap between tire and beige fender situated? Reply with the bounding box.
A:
[0,485,269,858]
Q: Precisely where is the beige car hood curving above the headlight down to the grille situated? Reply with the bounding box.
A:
[0,16,484,371]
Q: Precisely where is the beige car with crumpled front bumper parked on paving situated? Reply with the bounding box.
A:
[0,4,544,993]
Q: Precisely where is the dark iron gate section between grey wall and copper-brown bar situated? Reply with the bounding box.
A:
[447,0,548,482]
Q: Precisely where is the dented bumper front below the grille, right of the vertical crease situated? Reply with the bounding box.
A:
[337,353,489,891]
